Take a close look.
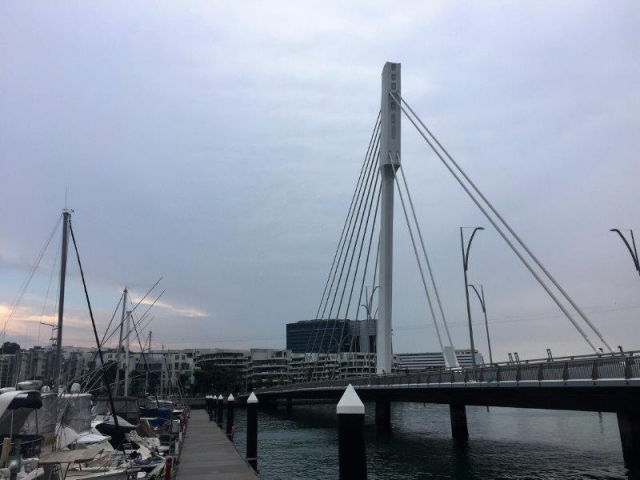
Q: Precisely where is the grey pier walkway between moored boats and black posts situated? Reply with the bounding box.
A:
[176,410,258,480]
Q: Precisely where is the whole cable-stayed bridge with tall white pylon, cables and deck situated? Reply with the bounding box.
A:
[250,63,640,466]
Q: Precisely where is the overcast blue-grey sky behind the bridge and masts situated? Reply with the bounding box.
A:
[0,0,640,360]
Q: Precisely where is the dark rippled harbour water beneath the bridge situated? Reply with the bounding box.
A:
[235,403,637,480]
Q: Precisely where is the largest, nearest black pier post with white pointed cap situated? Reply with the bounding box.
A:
[336,384,367,480]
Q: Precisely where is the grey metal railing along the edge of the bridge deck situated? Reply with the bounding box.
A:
[262,352,640,392]
